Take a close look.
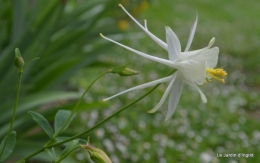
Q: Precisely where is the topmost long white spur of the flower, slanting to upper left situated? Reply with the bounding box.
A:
[119,4,167,50]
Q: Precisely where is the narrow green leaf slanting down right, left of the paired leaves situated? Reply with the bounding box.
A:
[28,111,53,138]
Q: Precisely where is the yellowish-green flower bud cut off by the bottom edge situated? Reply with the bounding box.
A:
[80,143,112,163]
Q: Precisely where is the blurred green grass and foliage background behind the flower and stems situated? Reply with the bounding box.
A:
[0,0,260,163]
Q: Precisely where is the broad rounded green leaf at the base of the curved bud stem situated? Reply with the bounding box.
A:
[54,110,72,134]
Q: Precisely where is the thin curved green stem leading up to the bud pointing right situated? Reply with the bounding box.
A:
[44,70,109,147]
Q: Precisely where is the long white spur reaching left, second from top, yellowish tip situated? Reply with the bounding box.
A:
[100,34,173,67]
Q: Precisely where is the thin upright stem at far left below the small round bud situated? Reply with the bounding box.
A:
[0,71,23,158]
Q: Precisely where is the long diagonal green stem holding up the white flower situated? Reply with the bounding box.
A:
[22,81,160,160]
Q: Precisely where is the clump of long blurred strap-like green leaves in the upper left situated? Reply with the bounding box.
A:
[0,0,124,158]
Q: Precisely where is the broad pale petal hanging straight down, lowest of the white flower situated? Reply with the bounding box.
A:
[165,80,183,121]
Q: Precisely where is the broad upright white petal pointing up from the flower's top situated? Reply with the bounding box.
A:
[166,27,181,61]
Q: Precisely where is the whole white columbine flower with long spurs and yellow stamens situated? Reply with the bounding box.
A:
[100,4,227,121]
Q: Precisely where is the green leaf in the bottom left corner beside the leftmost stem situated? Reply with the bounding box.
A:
[0,131,16,162]
